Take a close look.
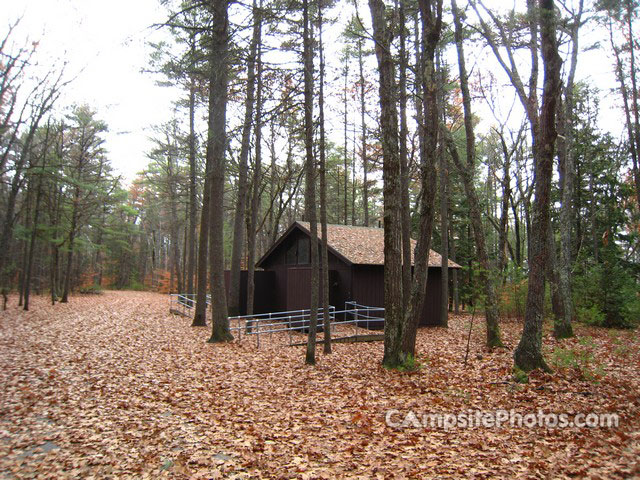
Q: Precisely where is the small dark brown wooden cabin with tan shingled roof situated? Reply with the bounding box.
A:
[256,222,460,325]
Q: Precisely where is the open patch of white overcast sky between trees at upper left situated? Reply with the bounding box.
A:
[6,0,181,179]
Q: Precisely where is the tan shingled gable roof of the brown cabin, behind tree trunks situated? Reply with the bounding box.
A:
[259,222,461,268]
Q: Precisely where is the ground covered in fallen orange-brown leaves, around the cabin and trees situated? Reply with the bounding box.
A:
[0,292,640,479]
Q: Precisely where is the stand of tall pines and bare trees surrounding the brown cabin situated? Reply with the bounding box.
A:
[0,0,640,371]
